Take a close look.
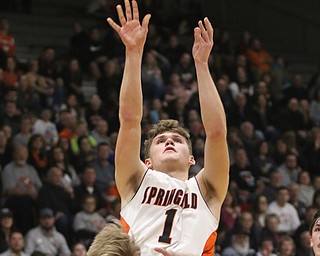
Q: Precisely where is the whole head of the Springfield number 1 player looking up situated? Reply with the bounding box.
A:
[144,119,195,171]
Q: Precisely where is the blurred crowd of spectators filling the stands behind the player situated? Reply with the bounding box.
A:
[0,1,320,256]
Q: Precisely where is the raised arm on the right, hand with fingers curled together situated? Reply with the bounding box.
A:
[192,18,229,214]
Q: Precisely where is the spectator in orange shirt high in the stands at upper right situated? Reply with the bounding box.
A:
[246,38,273,78]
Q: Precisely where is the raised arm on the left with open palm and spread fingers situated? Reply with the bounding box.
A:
[107,0,151,205]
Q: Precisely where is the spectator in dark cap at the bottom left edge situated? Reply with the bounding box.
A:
[0,208,15,253]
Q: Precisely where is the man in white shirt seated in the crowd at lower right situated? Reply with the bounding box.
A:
[268,187,300,235]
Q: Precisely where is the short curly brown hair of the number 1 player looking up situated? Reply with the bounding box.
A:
[144,119,192,159]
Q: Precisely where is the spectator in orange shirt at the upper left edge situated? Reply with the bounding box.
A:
[0,18,16,56]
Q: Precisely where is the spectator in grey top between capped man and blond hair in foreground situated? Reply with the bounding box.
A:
[73,195,106,248]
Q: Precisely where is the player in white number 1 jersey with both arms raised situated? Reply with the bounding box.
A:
[108,0,229,256]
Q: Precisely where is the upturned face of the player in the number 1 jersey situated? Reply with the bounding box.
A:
[146,132,194,169]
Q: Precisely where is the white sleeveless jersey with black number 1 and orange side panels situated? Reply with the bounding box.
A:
[121,169,218,256]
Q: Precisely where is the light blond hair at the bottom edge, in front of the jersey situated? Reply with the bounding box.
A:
[87,222,140,256]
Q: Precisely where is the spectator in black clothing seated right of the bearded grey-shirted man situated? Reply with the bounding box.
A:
[38,167,74,241]
